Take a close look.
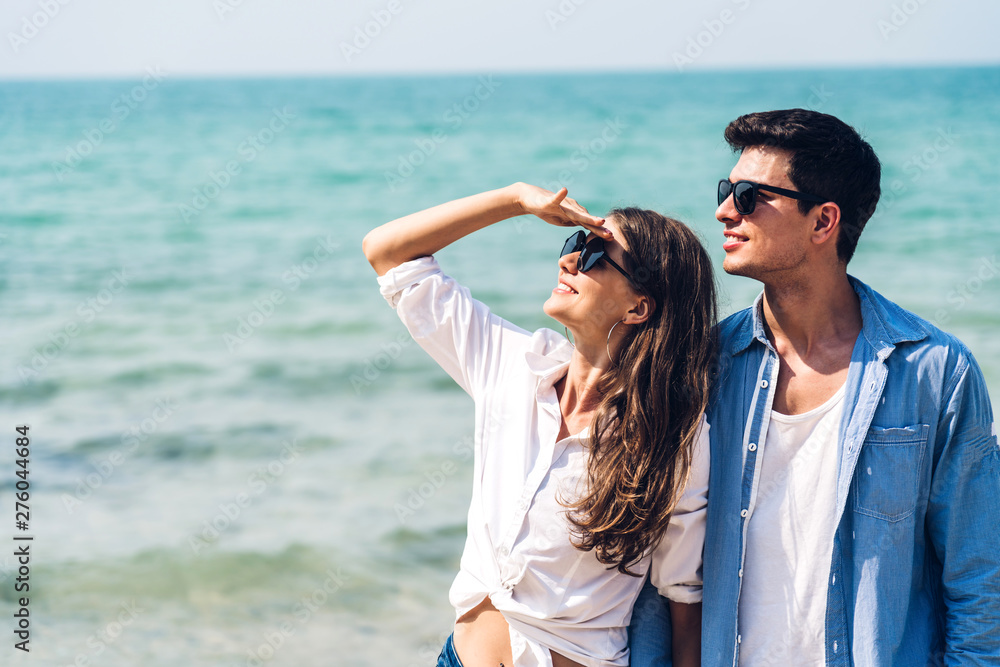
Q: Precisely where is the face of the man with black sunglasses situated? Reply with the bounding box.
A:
[715,147,811,282]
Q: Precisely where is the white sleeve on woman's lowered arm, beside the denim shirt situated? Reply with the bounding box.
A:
[649,415,710,604]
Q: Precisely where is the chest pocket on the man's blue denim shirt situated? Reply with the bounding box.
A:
[851,424,930,522]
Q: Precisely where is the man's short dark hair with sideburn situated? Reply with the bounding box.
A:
[725,109,882,264]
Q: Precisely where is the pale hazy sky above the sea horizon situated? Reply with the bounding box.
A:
[0,0,1000,78]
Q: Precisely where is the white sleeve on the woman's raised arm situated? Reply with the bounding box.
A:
[378,256,528,398]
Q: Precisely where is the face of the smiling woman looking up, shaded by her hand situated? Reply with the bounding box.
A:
[542,218,639,345]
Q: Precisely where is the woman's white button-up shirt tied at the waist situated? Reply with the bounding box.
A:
[378,257,709,667]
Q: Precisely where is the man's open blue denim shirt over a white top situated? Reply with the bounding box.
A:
[631,277,1000,667]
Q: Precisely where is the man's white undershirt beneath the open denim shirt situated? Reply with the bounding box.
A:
[739,386,844,667]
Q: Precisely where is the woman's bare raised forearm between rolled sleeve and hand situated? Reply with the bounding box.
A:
[361,183,525,276]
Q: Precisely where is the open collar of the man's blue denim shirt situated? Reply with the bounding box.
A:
[725,275,930,359]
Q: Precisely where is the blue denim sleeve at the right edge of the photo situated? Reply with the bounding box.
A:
[927,353,1000,665]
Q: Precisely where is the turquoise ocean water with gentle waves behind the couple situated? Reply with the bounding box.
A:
[0,68,1000,667]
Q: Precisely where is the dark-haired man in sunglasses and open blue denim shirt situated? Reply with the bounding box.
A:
[632,109,1000,667]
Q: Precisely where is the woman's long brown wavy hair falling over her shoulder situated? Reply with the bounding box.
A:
[562,207,718,576]
